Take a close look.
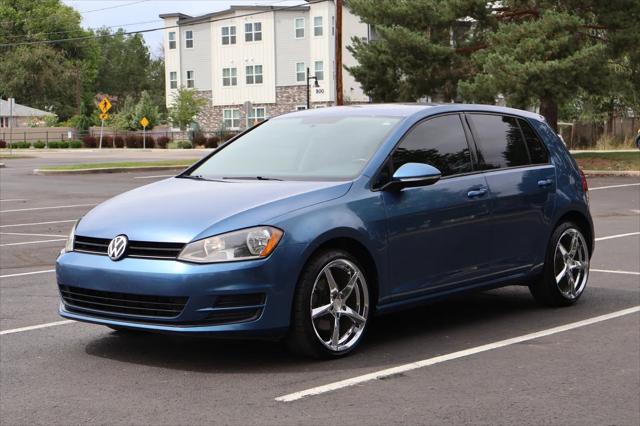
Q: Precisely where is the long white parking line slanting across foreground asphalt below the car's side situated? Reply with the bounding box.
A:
[276,305,640,402]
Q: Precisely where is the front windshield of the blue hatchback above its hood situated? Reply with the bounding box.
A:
[191,115,401,180]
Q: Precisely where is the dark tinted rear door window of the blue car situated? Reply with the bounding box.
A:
[468,114,529,170]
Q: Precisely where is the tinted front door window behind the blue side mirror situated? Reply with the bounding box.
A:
[392,115,472,176]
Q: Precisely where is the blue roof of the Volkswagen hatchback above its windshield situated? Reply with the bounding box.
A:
[281,103,544,121]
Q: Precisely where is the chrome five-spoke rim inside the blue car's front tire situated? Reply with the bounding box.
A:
[310,259,369,352]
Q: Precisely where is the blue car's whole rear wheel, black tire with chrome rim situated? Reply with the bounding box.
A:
[529,222,591,306]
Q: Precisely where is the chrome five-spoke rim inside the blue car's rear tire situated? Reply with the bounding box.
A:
[554,228,589,300]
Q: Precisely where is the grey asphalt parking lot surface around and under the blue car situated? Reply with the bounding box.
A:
[0,152,640,425]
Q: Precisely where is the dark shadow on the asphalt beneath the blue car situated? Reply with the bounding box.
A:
[85,287,543,373]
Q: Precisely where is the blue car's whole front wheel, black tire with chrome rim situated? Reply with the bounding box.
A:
[286,250,371,358]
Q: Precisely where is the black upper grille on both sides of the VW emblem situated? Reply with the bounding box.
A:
[73,235,184,259]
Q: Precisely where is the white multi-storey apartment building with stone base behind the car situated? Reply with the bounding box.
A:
[160,0,370,130]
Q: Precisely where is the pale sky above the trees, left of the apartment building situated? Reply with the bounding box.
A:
[62,0,302,56]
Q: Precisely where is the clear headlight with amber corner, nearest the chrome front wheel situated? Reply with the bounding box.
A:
[178,226,283,263]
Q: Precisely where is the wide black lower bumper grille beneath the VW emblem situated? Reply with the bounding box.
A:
[60,285,188,318]
